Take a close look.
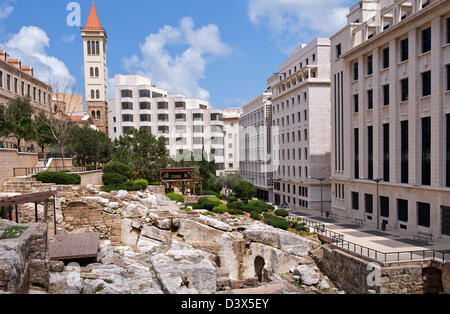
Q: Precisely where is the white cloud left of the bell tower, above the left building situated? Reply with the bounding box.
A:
[0,26,75,83]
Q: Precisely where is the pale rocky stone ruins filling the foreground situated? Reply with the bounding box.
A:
[0,186,343,294]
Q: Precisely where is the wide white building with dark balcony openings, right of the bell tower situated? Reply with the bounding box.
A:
[108,75,225,173]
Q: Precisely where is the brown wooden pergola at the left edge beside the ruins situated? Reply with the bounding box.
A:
[0,191,57,233]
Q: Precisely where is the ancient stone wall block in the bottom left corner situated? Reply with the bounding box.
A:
[0,220,49,294]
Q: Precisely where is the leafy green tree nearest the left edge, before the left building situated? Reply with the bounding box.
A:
[4,97,33,152]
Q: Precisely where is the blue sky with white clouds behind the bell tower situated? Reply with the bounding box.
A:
[0,0,354,108]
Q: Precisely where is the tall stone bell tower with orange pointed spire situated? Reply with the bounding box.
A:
[81,3,108,134]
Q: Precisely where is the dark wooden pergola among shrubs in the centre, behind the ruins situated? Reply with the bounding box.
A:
[159,167,203,195]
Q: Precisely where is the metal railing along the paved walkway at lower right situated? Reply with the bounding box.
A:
[290,217,450,263]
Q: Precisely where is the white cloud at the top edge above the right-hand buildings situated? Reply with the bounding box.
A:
[248,0,349,46]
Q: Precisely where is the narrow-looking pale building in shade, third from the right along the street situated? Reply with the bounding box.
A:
[239,92,273,202]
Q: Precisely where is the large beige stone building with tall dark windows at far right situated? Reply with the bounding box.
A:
[331,0,450,239]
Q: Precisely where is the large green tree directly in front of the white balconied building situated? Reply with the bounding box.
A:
[113,128,170,182]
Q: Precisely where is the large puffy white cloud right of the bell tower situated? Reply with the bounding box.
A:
[125,17,231,99]
